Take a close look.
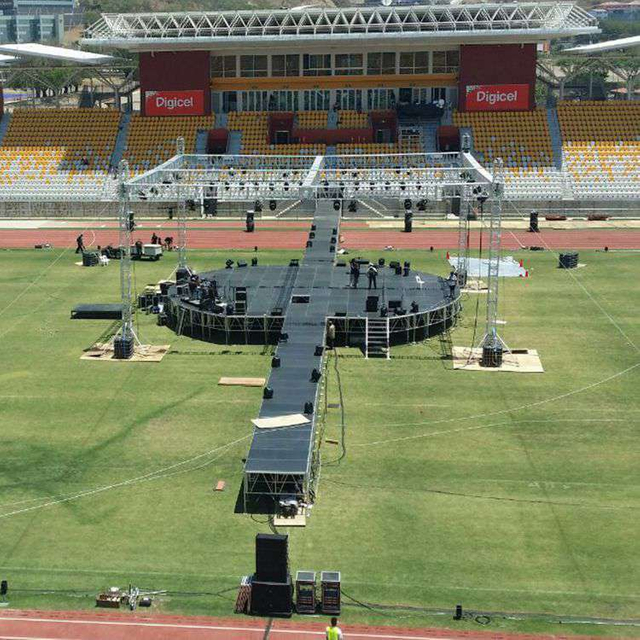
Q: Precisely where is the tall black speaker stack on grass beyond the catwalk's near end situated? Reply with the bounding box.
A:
[251,533,293,617]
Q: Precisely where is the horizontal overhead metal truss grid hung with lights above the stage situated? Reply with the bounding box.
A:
[127,153,491,202]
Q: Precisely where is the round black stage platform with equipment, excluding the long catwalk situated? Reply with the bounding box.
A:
[162,260,461,346]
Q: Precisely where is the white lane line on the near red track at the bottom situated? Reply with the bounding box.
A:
[0,616,453,640]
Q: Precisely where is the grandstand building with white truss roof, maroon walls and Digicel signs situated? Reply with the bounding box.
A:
[84,2,598,116]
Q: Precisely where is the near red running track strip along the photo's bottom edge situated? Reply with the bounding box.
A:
[0,610,603,640]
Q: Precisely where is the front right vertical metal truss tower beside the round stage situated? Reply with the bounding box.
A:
[480,158,509,351]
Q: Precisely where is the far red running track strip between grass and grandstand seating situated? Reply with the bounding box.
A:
[0,228,640,251]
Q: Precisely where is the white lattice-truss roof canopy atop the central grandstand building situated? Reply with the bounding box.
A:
[82,2,599,51]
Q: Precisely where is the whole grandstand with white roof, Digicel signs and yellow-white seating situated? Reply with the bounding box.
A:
[0,1,640,212]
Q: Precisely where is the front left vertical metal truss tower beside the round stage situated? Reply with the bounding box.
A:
[118,160,138,342]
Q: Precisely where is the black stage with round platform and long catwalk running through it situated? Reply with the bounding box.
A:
[163,201,460,507]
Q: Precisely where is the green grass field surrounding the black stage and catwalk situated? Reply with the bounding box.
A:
[0,245,640,636]
